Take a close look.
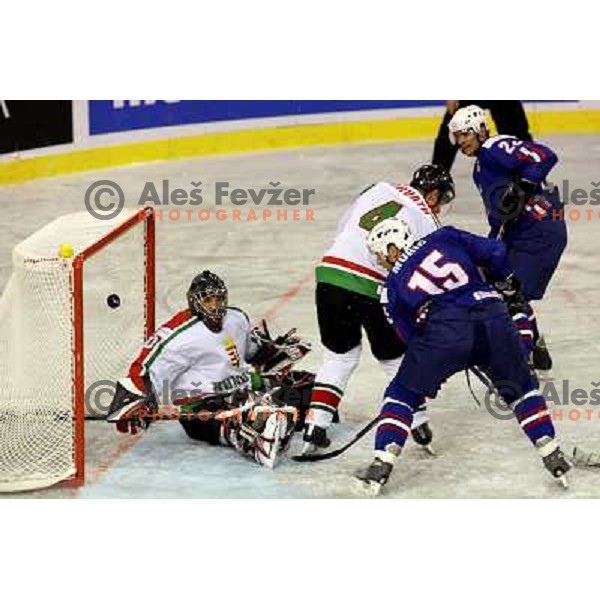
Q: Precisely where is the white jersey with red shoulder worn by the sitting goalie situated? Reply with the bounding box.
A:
[129,308,256,405]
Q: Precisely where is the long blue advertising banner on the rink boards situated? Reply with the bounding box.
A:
[89,100,444,135]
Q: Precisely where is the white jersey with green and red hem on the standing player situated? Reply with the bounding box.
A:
[316,181,440,298]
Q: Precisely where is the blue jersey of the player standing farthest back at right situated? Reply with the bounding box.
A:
[473,135,558,234]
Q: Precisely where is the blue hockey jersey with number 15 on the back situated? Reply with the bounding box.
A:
[381,227,511,341]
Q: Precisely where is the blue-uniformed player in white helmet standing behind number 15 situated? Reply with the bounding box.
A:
[448,105,567,370]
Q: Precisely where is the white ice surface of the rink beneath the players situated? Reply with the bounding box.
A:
[0,136,600,498]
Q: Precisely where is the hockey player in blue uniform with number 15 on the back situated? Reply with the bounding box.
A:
[356,218,570,493]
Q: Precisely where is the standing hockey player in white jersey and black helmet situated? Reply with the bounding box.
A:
[304,164,454,453]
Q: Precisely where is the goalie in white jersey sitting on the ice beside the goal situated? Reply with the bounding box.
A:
[107,271,313,467]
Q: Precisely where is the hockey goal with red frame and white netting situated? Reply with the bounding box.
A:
[0,209,155,492]
